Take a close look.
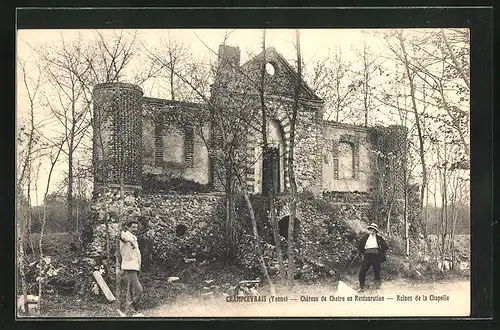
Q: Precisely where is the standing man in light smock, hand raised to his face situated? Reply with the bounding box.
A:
[118,220,143,316]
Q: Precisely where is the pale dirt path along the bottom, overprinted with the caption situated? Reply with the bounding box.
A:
[145,280,470,317]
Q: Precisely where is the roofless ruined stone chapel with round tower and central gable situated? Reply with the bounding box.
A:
[88,45,406,266]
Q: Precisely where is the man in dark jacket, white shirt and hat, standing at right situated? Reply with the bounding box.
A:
[357,223,388,291]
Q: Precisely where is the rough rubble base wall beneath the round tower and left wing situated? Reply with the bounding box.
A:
[87,191,225,262]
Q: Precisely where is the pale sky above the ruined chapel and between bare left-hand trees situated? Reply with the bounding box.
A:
[16,29,468,205]
